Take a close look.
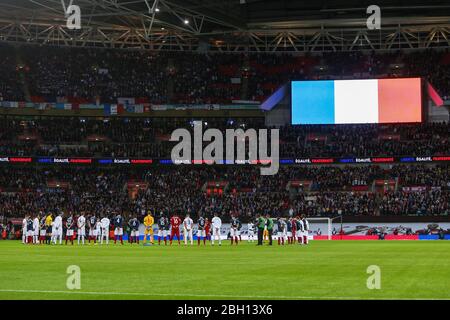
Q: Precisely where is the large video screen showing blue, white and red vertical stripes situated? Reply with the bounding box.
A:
[292,78,422,124]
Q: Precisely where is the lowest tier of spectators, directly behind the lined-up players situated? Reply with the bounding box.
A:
[0,165,450,218]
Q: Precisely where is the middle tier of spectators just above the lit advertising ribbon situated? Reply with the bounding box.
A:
[0,117,450,158]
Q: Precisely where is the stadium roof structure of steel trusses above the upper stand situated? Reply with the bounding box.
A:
[0,0,450,52]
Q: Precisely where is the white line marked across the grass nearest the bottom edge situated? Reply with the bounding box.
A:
[0,289,449,300]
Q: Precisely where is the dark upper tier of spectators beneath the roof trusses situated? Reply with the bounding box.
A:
[0,45,450,104]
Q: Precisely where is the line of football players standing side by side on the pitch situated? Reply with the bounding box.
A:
[22,211,309,245]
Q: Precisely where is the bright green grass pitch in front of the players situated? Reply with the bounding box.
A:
[0,241,450,300]
